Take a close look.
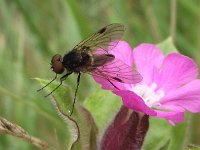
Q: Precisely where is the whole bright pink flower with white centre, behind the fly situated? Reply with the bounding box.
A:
[93,41,200,125]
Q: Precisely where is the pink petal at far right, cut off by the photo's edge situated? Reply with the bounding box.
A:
[160,79,200,113]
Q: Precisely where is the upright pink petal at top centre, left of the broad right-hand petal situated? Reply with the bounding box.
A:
[133,44,164,84]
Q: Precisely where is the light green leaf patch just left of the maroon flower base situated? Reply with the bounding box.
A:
[84,89,121,137]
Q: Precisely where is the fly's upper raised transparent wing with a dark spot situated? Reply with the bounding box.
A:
[73,23,124,52]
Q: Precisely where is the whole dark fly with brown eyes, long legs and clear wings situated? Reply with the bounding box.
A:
[38,23,141,115]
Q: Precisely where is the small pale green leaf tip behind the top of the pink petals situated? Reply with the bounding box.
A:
[157,37,178,54]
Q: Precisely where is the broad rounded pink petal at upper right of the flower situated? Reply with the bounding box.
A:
[154,53,198,92]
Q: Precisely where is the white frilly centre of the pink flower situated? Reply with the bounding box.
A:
[132,83,165,107]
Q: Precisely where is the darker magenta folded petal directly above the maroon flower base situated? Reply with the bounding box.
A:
[113,90,156,116]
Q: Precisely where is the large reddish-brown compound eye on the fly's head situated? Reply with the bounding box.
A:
[51,54,64,74]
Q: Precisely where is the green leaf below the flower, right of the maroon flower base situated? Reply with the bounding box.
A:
[143,117,187,150]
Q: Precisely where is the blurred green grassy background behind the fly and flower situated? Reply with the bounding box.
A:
[0,0,200,150]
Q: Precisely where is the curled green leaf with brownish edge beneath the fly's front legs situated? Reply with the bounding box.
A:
[36,78,97,150]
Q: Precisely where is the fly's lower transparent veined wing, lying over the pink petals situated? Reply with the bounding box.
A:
[92,58,142,84]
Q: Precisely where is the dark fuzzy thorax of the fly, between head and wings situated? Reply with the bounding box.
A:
[62,50,91,72]
